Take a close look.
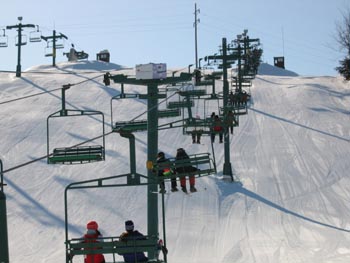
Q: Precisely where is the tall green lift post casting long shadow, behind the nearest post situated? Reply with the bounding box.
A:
[222,38,233,180]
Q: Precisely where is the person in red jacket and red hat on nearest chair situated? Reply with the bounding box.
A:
[83,221,106,263]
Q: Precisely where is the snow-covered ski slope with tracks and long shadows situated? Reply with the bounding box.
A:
[0,62,350,263]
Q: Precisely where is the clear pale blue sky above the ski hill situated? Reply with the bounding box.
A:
[0,0,349,75]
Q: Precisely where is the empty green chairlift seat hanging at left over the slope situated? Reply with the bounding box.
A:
[47,84,105,164]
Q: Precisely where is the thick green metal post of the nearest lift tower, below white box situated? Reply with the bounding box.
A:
[147,83,158,258]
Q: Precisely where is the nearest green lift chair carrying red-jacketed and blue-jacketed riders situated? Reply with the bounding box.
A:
[64,173,167,263]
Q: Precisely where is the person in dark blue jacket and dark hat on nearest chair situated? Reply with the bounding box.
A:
[120,220,148,263]
